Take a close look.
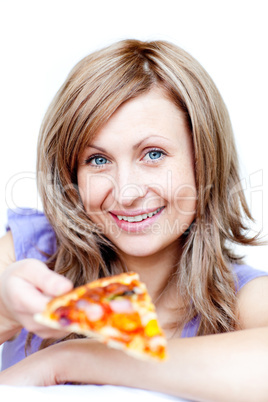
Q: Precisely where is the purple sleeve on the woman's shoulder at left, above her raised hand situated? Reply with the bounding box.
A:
[4,208,56,261]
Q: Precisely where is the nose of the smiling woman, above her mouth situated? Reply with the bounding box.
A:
[113,168,148,207]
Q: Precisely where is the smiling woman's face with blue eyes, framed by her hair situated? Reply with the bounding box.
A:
[78,89,196,257]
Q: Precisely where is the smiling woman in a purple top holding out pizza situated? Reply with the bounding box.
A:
[0,40,268,401]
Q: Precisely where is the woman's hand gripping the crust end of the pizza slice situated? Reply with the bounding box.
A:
[0,259,73,342]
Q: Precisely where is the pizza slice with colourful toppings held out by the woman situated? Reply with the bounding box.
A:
[34,272,167,361]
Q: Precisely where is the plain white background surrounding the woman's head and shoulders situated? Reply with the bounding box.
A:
[0,0,268,271]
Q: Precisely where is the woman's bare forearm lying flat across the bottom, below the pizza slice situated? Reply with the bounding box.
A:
[0,328,268,402]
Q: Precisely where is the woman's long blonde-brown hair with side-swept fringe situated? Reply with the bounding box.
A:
[34,40,256,346]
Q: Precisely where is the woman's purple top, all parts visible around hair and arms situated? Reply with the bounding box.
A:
[2,209,268,370]
